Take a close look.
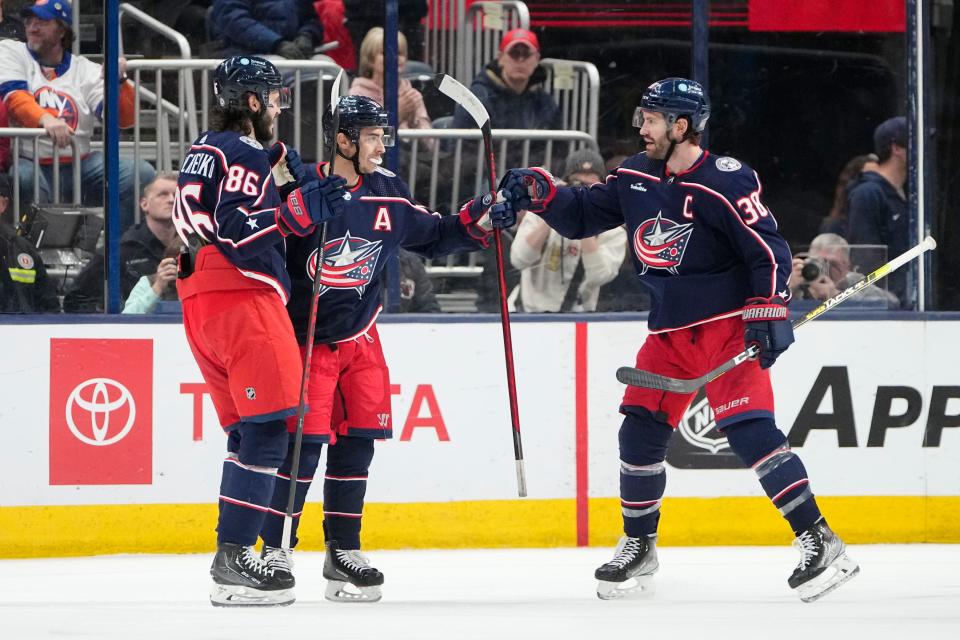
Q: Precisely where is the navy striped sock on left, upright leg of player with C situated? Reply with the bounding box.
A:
[620,407,673,538]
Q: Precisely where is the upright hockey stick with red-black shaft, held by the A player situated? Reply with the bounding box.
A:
[434,73,527,498]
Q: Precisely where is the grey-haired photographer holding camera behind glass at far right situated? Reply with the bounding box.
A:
[790,233,900,309]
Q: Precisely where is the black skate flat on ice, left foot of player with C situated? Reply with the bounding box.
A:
[593,534,660,600]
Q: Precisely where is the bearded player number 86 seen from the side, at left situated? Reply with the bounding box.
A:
[173,56,344,606]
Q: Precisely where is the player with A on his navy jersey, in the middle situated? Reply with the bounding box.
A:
[255,96,510,600]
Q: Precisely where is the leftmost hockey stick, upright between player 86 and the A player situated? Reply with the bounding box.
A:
[281,69,343,551]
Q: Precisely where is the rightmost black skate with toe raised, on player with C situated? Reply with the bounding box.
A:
[787,518,860,602]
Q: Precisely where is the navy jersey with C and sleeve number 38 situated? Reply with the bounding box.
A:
[544,151,791,332]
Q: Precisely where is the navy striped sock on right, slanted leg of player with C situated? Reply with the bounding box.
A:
[724,418,820,535]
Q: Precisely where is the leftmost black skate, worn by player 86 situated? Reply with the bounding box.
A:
[210,542,295,607]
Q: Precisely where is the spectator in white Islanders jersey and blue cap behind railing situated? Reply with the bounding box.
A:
[0,0,154,228]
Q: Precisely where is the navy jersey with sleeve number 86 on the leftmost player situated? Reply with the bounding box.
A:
[173,131,290,304]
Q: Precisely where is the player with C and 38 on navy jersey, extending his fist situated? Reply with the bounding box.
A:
[501,78,852,599]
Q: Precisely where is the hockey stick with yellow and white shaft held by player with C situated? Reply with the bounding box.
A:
[617,236,937,393]
